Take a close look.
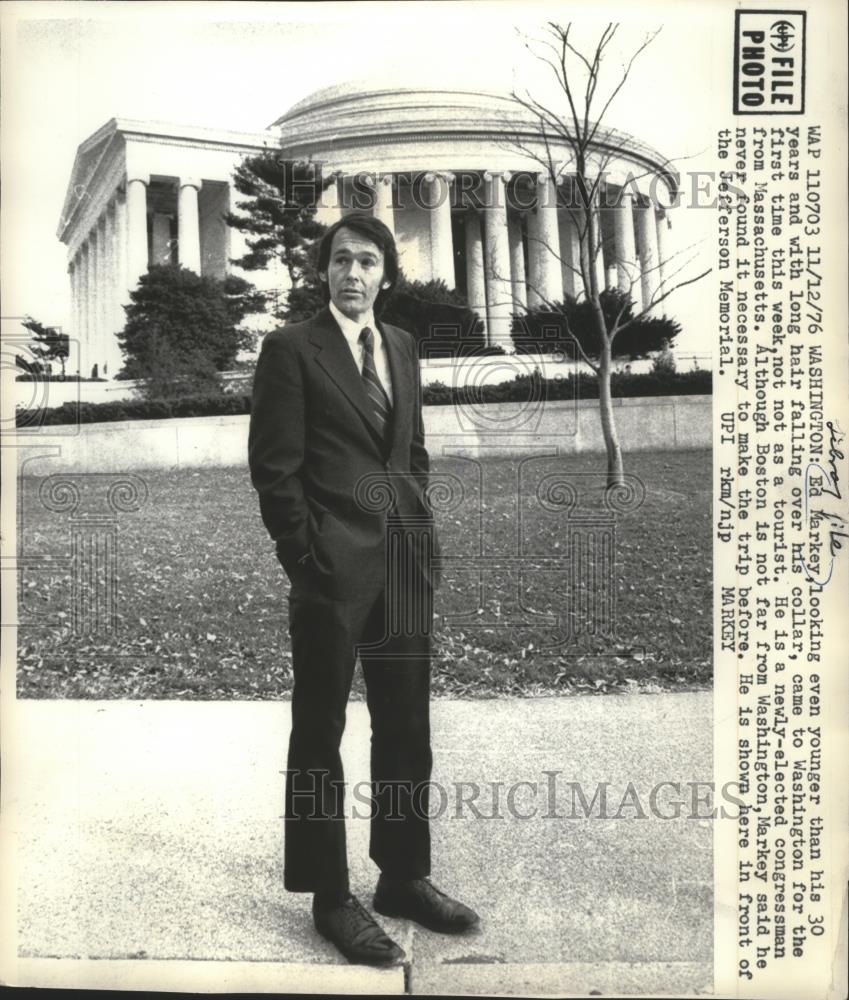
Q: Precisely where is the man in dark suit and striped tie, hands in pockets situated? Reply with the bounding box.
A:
[249,213,478,964]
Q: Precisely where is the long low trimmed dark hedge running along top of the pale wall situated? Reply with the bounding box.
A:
[17,370,712,427]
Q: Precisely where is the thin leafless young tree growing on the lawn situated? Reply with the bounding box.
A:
[504,22,710,487]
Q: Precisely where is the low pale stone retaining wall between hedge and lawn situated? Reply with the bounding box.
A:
[17,396,712,475]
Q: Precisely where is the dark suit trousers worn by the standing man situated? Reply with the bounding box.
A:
[284,548,433,892]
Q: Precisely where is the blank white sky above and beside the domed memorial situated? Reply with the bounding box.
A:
[0,0,714,354]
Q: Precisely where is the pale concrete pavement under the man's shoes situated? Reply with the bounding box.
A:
[4,693,713,995]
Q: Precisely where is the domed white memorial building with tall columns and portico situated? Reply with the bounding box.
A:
[58,85,678,378]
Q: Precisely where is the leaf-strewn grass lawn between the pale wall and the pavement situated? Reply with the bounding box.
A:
[18,451,711,699]
